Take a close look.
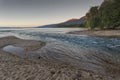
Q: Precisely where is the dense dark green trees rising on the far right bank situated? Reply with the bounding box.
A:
[86,0,120,29]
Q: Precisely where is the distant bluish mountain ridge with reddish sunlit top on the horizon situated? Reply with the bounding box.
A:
[37,16,86,28]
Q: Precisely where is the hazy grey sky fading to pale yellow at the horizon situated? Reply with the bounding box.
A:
[0,0,103,27]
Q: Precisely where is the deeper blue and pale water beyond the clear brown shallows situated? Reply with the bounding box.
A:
[0,28,120,53]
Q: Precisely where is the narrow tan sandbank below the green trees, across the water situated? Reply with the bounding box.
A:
[68,30,120,38]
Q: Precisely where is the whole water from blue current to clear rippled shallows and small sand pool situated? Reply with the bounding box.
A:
[0,28,120,74]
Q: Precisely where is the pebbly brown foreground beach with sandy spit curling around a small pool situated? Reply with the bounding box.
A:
[0,36,120,80]
